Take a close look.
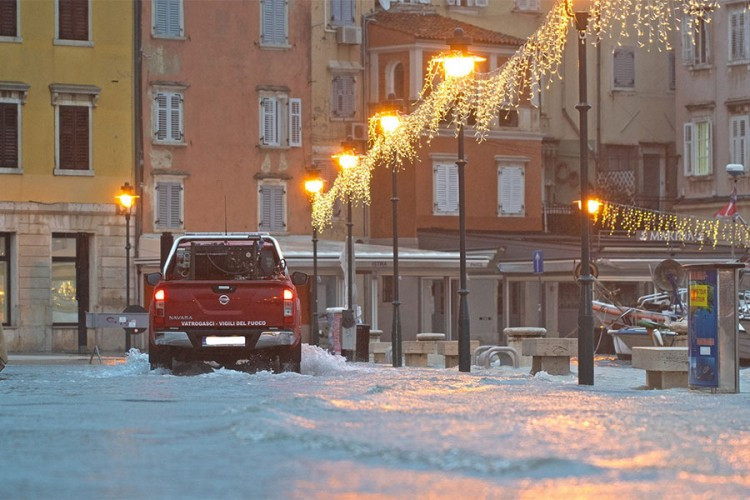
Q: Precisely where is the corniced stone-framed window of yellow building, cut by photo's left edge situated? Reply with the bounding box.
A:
[0,82,29,173]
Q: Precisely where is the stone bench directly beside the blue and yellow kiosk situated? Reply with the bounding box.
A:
[632,347,688,389]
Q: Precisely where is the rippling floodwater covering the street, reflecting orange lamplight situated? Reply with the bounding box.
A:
[0,346,750,499]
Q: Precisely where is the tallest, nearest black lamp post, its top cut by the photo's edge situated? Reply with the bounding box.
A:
[573,0,594,385]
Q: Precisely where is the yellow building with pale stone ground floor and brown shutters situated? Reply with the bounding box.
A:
[0,0,135,352]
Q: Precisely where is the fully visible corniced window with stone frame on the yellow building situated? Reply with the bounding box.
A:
[50,84,100,175]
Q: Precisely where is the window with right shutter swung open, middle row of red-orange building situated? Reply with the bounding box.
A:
[259,93,302,147]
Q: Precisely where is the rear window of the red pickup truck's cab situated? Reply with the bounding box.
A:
[167,241,283,281]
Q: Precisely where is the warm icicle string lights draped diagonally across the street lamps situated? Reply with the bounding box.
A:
[312,0,724,230]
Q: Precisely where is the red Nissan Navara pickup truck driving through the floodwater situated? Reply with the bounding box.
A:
[148,233,307,372]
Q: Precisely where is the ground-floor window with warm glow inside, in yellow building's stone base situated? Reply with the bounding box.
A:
[50,233,78,325]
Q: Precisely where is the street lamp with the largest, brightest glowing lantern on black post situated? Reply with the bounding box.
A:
[441,28,484,372]
